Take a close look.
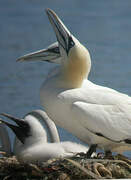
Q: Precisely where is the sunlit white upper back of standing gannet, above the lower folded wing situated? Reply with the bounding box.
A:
[58,83,131,105]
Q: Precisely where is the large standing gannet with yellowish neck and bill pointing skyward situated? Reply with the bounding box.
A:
[18,9,131,156]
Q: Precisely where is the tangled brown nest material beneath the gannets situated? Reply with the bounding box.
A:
[0,155,131,180]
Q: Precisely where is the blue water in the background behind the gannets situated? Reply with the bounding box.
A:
[0,0,131,156]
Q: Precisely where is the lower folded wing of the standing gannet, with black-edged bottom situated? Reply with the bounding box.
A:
[72,101,131,143]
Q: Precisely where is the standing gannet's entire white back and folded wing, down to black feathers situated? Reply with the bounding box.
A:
[58,81,131,143]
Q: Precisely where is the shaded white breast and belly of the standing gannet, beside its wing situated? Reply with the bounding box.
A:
[40,82,90,142]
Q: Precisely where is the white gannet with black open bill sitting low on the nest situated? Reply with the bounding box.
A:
[0,110,88,162]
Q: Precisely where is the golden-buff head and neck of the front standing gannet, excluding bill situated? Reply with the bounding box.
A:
[62,37,91,87]
